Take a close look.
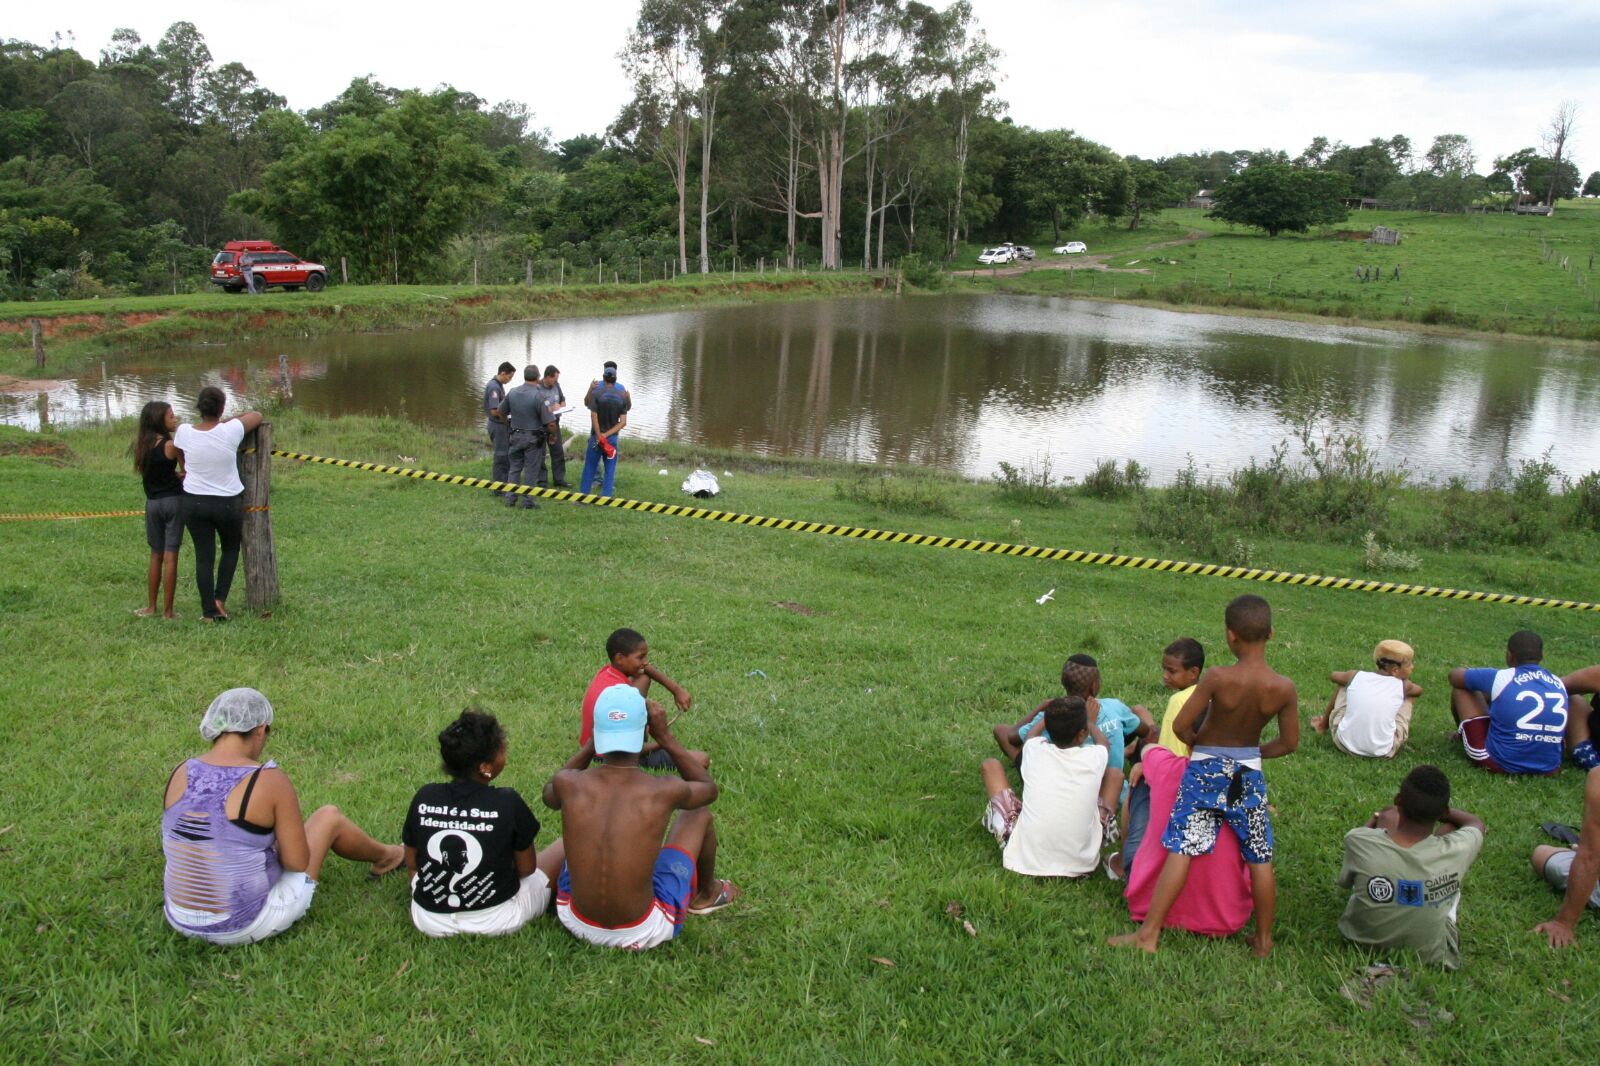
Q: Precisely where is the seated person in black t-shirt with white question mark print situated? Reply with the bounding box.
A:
[400,707,566,936]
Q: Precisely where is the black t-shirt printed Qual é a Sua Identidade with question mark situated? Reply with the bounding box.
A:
[400,781,539,914]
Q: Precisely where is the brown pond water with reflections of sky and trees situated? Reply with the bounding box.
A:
[0,296,1600,482]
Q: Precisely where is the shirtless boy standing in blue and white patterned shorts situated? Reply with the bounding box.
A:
[1107,595,1299,956]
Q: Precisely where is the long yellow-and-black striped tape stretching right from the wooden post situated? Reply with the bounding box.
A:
[272,448,1600,611]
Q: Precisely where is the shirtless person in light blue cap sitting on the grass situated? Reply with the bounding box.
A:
[544,683,739,951]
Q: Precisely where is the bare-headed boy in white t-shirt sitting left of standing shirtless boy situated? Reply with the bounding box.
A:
[982,696,1122,877]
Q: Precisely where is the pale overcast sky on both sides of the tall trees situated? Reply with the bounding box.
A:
[9,0,1600,174]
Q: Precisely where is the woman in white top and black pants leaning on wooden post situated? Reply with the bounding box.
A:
[173,386,261,623]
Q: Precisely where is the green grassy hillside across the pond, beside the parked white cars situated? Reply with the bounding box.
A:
[957,200,1600,339]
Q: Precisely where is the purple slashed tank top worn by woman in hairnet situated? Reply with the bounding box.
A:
[162,759,283,935]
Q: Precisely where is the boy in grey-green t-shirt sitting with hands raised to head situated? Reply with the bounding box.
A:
[1339,765,1483,970]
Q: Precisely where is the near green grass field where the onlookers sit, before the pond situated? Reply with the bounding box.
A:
[0,415,1600,1063]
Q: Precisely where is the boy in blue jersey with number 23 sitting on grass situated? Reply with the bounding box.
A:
[1450,629,1568,773]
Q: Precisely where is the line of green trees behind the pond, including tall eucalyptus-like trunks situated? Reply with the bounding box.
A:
[0,9,1600,299]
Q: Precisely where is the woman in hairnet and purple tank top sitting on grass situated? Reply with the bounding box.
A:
[162,688,405,944]
